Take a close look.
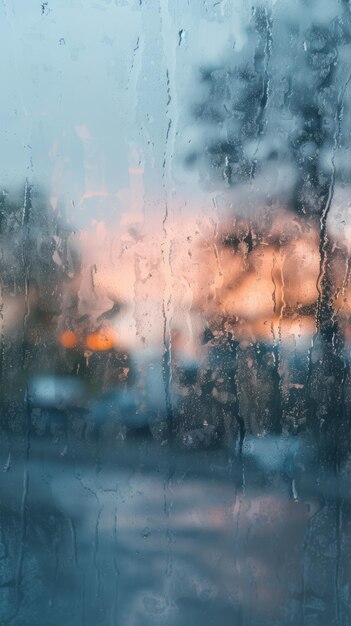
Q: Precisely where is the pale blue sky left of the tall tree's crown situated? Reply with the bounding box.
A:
[0,0,248,225]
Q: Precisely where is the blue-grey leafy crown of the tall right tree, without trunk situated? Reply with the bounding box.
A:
[187,0,351,215]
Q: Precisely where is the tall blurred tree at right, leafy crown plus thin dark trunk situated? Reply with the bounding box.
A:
[187,0,351,448]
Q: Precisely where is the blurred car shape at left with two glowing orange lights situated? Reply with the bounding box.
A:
[27,316,143,435]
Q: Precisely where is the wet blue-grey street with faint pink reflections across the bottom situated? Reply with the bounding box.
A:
[0,426,351,626]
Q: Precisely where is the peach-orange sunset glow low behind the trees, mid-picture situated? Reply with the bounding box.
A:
[56,200,348,356]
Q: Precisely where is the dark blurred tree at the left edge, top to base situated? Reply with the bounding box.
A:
[0,182,72,428]
